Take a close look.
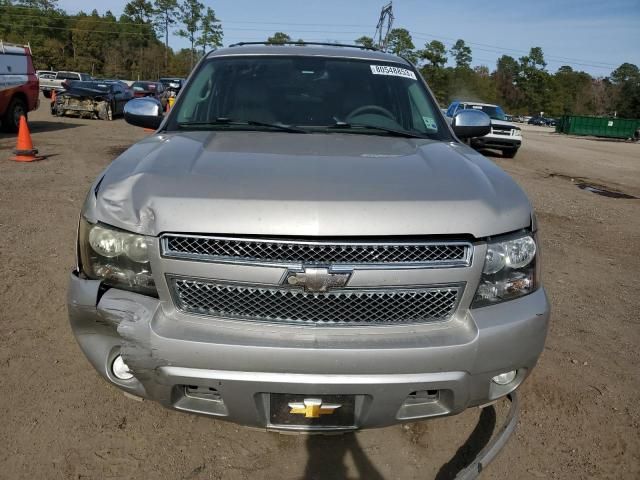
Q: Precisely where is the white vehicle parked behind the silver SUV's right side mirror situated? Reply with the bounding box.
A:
[446,101,522,158]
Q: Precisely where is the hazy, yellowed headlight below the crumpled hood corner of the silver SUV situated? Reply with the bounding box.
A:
[78,218,157,296]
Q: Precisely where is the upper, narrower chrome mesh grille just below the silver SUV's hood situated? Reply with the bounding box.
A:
[162,234,471,266]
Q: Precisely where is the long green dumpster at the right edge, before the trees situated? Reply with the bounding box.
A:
[556,115,640,139]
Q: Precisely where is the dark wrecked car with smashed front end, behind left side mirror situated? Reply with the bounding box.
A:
[51,81,133,120]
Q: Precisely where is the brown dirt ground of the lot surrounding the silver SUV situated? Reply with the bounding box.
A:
[0,99,640,480]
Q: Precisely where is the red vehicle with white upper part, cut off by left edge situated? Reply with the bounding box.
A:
[0,41,40,132]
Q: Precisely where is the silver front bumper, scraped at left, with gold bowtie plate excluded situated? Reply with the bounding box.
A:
[68,274,549,430]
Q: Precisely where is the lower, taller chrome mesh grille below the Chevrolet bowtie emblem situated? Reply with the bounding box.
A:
[169,278,462,325]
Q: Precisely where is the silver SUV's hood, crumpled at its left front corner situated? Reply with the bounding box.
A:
[84,131,531,237]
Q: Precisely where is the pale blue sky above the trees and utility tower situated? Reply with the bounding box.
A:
[59,0,640,76]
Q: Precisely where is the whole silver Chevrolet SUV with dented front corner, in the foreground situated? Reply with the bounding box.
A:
[69,44,549,446]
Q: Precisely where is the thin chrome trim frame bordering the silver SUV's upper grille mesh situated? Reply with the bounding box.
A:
[160,233,473,272]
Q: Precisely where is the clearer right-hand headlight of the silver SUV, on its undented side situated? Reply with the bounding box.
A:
[471,234,538,308]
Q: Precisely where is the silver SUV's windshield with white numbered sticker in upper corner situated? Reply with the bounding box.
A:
[167,56,449,139]
